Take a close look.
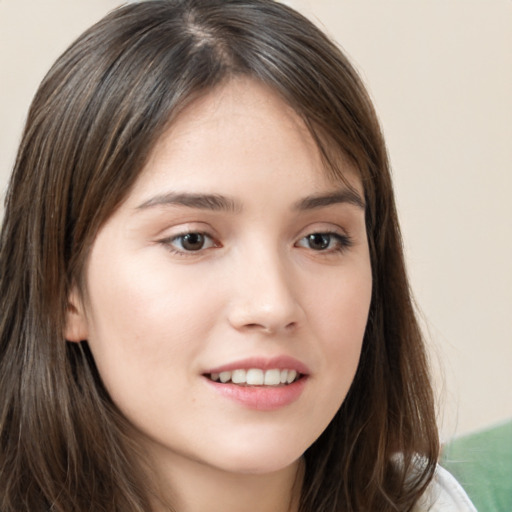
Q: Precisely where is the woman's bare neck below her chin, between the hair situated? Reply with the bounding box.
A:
[147,450,303,512]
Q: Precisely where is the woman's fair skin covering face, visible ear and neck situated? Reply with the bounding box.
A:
[66,78,372,512]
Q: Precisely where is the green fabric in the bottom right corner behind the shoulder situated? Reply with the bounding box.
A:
[441,421,512,512]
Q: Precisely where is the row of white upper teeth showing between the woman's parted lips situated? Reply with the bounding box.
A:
[205,368,303,386]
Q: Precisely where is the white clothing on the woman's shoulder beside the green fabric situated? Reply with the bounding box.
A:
[413,466,476,512]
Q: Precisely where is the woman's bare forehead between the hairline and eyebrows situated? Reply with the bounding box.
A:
[129,77,361,204]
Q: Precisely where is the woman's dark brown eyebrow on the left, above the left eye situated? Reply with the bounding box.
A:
[137,192,242,213]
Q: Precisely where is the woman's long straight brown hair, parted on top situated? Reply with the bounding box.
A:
[0,0,438,512]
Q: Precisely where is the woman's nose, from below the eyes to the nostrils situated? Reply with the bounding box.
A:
[228,249,304,334]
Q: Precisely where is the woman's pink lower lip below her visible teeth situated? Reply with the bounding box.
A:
[204,376,307,411]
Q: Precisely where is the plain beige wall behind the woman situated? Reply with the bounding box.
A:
[0,0,512,436]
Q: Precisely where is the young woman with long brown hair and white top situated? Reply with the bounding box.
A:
[0,0,472,512]
